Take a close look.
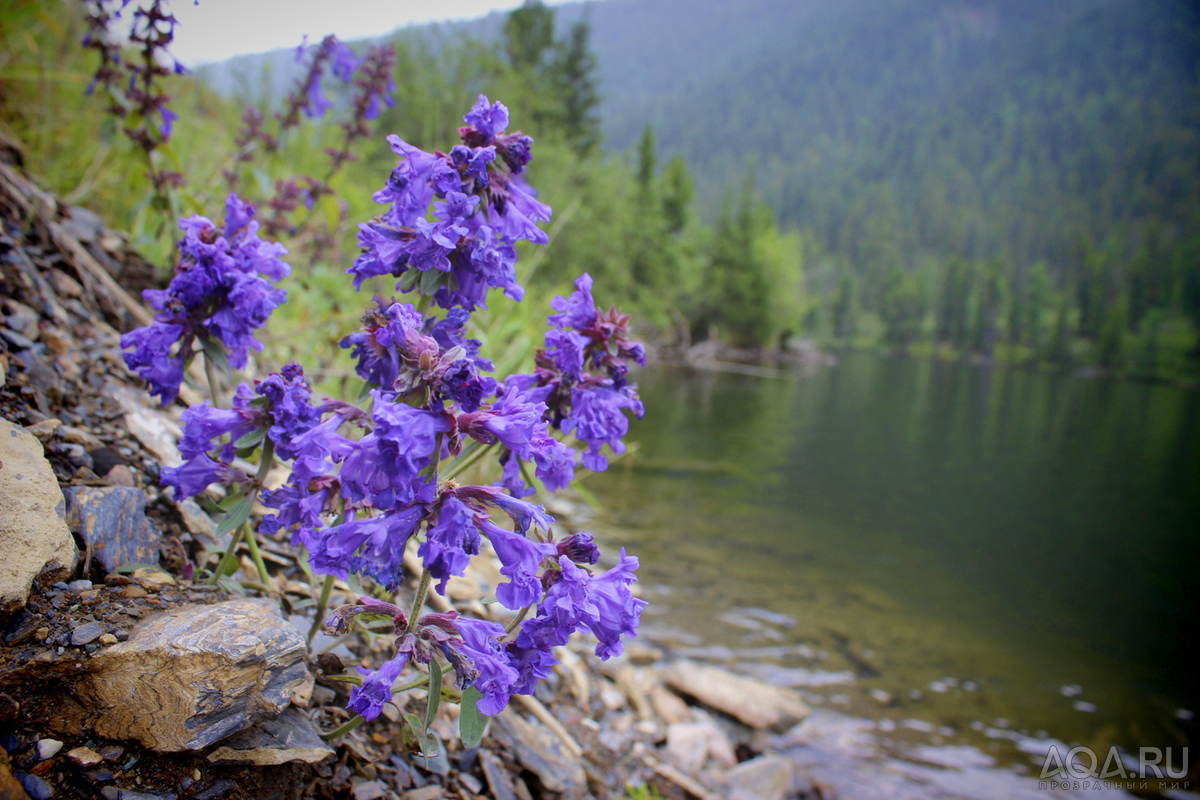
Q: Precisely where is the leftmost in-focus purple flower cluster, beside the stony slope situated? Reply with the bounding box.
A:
[121,194,292,405]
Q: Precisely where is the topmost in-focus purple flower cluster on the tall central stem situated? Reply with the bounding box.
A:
[347,95,551,311]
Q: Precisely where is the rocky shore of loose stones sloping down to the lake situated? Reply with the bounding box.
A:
[0,134,1132,800]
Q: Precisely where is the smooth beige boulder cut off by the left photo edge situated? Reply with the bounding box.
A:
[0,420,76,610]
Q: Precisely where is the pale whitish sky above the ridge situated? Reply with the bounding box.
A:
[172,0,563,67]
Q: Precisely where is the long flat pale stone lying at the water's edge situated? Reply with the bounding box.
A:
[660,661,810,729]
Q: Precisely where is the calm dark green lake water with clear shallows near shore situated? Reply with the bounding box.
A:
[586,355,1200,763]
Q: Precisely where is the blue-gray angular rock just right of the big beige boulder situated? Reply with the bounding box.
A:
[64,486,162,572]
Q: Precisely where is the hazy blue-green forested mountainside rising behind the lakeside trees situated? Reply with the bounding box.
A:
[200,0,1200,286]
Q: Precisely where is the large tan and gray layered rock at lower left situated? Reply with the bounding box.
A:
[74,599,307,752]
